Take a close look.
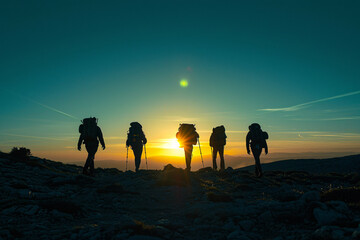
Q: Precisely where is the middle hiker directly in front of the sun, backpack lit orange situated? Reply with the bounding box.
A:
[176,123,199,171]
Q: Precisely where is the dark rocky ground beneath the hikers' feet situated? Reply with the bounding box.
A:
[0,154,360,240]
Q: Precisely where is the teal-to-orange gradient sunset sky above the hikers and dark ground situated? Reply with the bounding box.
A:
[0,0,360,162]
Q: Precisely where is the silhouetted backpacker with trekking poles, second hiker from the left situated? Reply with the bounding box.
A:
[126,122,147,172]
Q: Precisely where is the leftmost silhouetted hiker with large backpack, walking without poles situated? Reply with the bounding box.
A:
[78,117,105,176]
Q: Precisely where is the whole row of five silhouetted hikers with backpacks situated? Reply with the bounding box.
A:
[78,117,269,177]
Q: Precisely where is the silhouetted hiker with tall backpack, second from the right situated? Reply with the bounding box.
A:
[210,125,227,170]
